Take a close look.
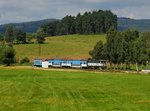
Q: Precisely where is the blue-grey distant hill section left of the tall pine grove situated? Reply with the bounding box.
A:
[0,19,57,33]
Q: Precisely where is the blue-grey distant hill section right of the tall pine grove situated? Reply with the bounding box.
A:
[118,18,150,31]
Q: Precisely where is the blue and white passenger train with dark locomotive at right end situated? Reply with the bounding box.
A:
[33,59,107,69]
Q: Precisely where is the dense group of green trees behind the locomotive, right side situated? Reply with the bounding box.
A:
[89,28,150,71]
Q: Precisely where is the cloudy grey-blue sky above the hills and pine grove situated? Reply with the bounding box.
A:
[0,0,150,24]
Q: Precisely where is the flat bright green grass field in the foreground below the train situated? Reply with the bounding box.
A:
[0,68,150,111]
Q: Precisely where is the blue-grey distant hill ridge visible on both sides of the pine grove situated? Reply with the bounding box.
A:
[0,17,150,33]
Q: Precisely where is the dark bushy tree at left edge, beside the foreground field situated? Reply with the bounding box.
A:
[1,45,16,66]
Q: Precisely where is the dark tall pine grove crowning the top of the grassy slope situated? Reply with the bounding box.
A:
[41,10,117,36]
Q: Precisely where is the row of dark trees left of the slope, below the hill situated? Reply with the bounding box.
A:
[0,25,46,44]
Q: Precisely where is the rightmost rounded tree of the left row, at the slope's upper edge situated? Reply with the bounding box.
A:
[36,28,46,44]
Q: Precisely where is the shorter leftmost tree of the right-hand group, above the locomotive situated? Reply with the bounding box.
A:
[89,41,104,60]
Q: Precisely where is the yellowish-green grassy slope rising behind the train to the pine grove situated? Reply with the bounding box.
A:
[14,35,105,60]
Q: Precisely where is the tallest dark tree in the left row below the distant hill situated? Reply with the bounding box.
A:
[5,25,14,43]
